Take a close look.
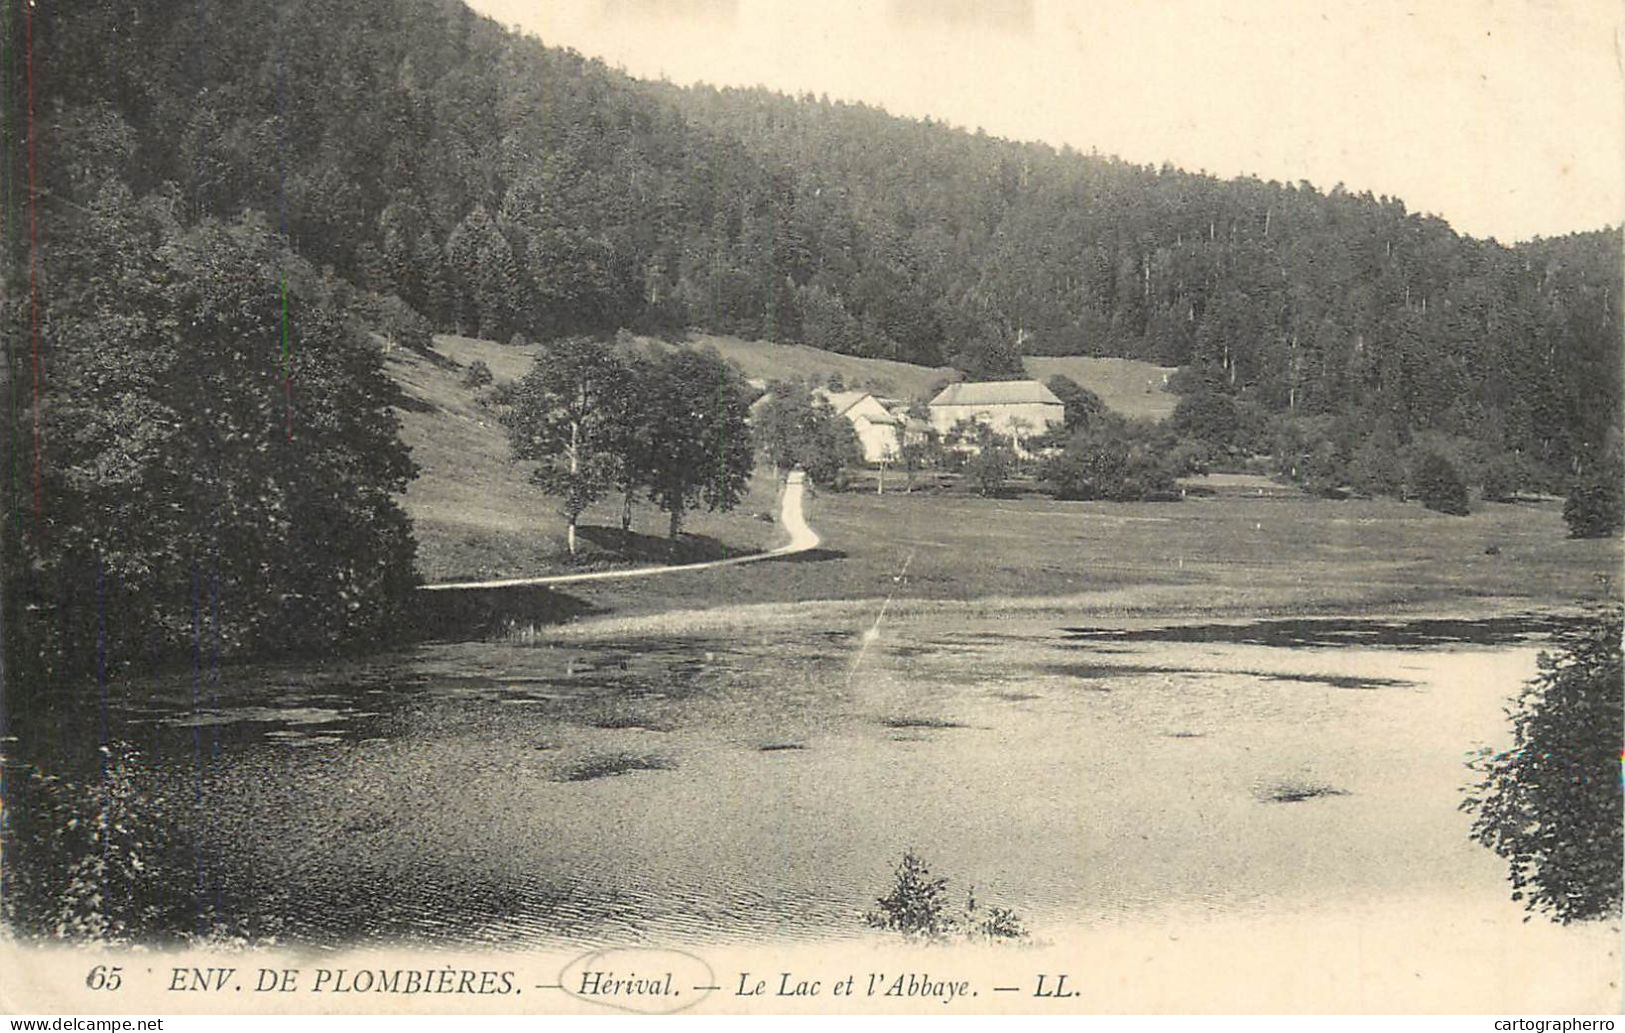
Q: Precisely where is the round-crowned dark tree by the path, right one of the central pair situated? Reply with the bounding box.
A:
[644,348,754,539]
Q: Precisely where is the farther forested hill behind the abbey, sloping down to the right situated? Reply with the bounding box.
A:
[666,86,1620,463]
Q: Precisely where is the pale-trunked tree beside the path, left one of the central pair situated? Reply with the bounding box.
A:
[502,338,629,555]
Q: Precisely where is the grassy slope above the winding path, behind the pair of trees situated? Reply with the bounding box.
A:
[385,338,780,581]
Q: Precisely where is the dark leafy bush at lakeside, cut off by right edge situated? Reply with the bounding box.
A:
[1461,607,1625,923]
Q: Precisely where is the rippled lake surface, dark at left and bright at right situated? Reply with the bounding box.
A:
[7,617,1573,945]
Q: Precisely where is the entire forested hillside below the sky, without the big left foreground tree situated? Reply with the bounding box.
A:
[22,0,1620,465]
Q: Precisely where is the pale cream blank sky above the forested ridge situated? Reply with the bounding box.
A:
[473,0,1625,242]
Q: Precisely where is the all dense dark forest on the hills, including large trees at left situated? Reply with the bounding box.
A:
[0,0,1620,665]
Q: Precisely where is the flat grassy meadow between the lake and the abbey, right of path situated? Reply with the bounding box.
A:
[549,494,1622,624]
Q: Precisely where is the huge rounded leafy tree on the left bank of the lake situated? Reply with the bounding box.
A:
[8,196,416,658]
